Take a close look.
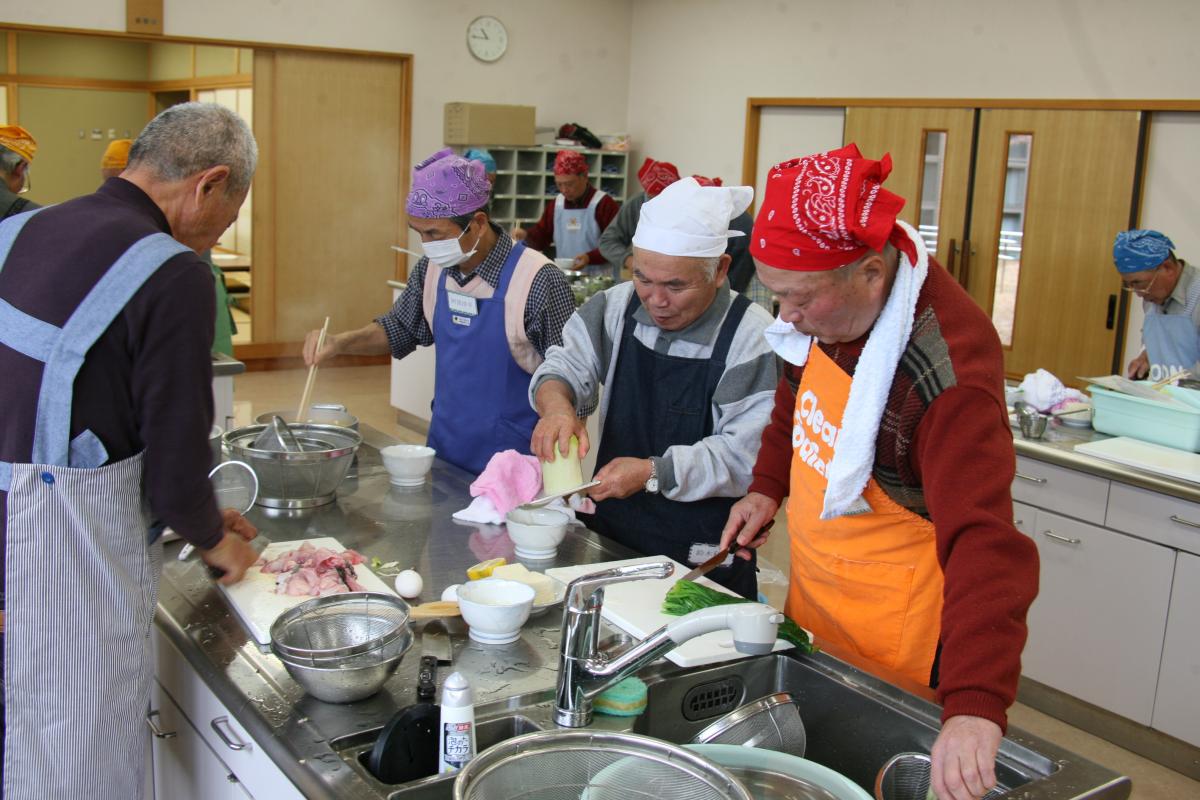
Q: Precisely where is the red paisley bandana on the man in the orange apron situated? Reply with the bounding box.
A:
[750,144,917,272]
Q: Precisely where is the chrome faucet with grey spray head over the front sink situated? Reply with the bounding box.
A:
[554,561,784,728]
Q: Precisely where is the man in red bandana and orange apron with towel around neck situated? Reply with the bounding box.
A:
[721,145,1038,800]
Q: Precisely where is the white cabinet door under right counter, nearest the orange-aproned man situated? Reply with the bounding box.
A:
[1021,509,1175,724]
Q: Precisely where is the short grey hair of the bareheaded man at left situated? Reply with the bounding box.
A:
[128,103,258,194]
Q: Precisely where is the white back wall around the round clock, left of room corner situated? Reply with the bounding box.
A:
[0,0,632,189]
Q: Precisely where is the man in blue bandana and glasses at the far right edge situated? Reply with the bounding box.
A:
[1112,230,1200,380]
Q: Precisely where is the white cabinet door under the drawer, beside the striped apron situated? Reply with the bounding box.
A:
[150,682,251,800]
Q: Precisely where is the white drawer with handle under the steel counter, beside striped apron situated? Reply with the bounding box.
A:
[154,628,304,800]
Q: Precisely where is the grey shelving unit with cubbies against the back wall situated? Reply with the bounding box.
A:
[478,145,629,230]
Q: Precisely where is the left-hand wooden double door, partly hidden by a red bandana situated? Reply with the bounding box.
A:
[845,107,974,275]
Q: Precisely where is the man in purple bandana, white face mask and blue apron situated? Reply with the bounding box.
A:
[304,149,575,474]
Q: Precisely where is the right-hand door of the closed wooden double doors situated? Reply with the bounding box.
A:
[961,109,1140,383]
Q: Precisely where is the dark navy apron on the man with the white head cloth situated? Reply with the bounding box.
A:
[581,291,758,600]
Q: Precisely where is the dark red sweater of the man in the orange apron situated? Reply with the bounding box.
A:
[750,259,1038,729]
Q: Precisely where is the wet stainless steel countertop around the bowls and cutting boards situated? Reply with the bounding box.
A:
[155,426,632,798]
